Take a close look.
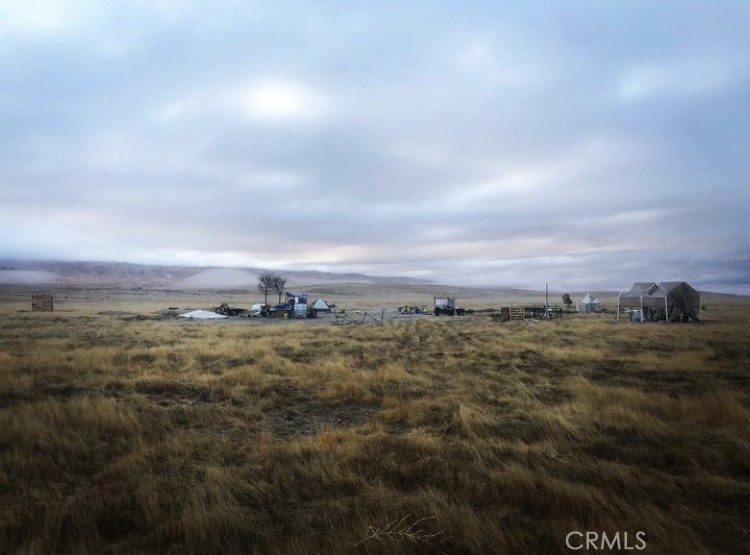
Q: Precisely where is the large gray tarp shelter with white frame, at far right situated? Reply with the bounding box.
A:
[617,281,701,322]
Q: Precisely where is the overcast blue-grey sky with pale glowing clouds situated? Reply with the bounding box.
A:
[0,0,750,293]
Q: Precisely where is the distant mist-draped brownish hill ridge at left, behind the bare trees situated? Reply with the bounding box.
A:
[0,260,430,289]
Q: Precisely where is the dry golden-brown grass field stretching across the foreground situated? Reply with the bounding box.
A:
[0,292,750,555]
